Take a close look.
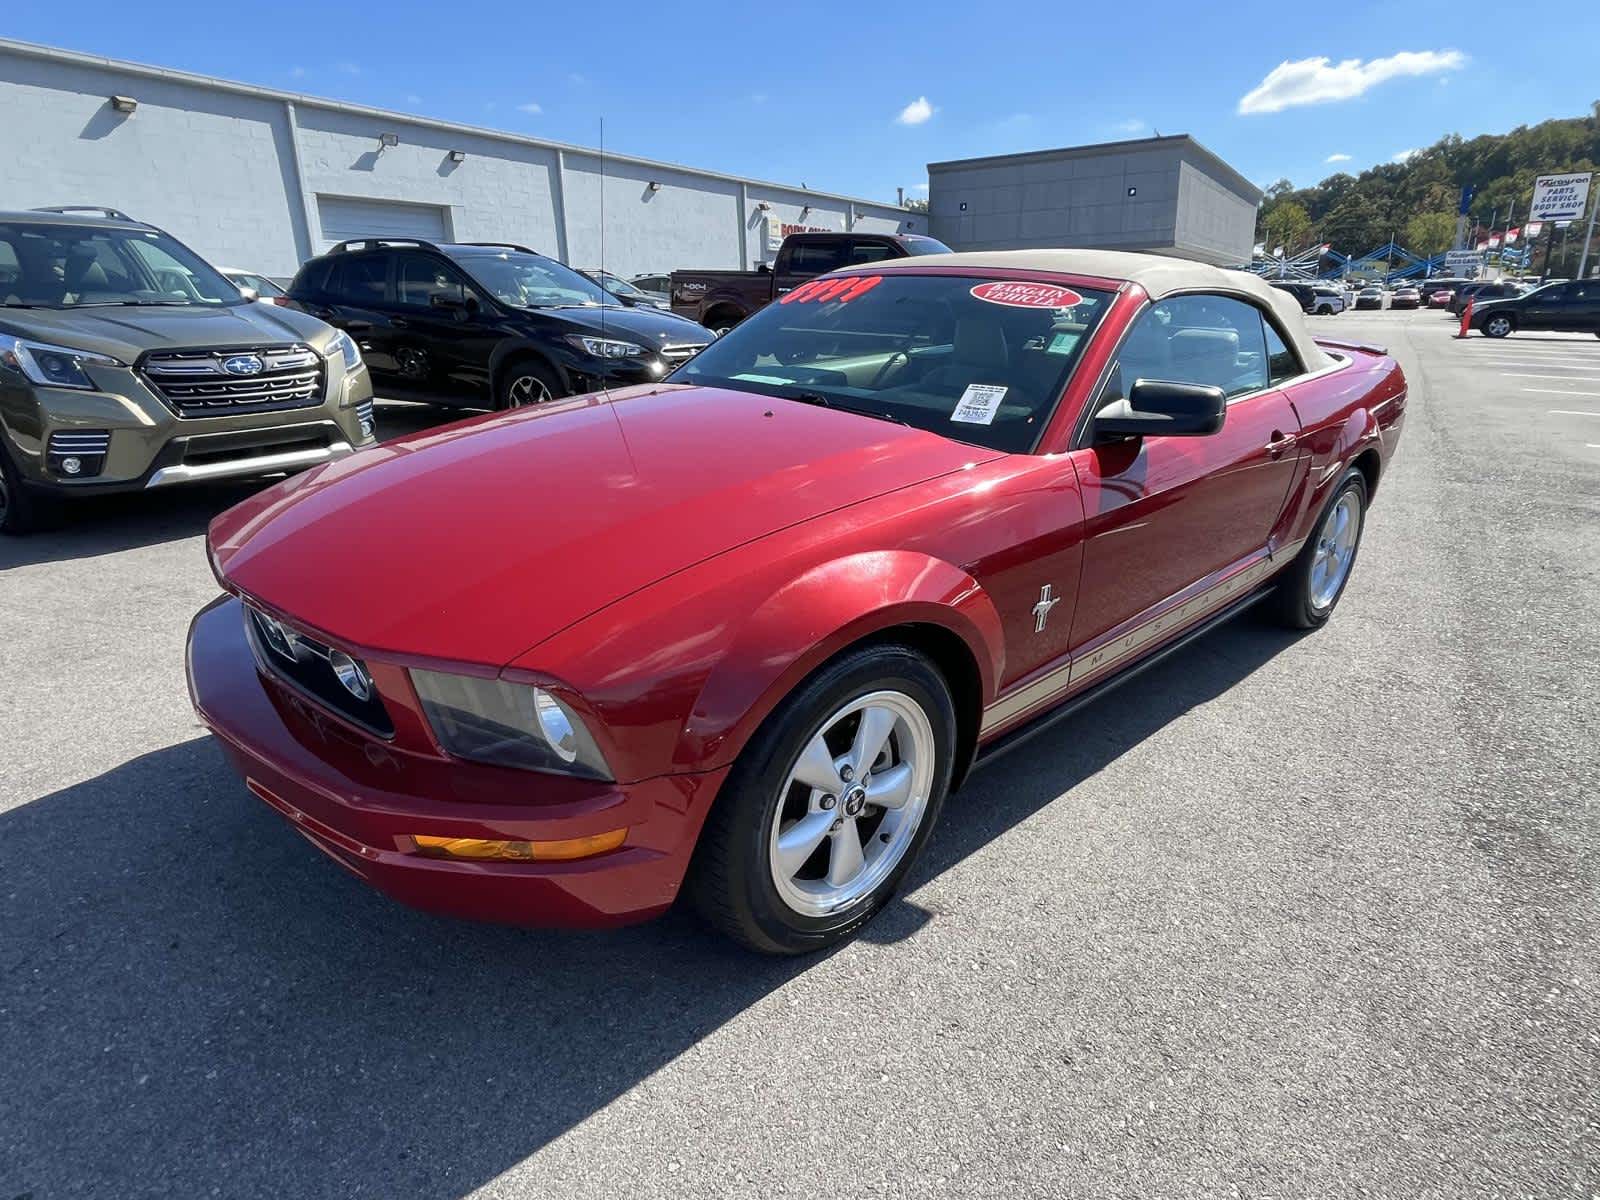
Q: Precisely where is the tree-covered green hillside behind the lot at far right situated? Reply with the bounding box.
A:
[1256,101,1600,264]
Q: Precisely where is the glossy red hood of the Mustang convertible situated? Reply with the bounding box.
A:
[211,384,998,667]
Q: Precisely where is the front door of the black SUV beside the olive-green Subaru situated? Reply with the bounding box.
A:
[390,250,499,405]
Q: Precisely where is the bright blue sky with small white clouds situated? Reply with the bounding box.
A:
[0,0,1600,198]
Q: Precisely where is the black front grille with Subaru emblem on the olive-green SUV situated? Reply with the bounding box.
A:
[139,342,328,416]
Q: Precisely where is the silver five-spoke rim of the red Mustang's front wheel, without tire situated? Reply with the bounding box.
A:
[768,691,934,917]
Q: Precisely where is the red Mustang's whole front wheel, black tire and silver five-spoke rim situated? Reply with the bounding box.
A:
[690,645,955,954]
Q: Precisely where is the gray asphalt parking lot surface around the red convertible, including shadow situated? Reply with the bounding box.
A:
[0,310,1600,1200]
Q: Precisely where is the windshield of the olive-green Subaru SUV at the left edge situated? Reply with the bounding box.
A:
[0,221,246,309]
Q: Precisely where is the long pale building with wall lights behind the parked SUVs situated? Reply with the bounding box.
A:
[0,38,928,277]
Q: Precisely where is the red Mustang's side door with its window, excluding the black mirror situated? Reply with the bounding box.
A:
[1072,294,1299,666]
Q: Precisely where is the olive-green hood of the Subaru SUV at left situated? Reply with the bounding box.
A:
[0,301,334,363]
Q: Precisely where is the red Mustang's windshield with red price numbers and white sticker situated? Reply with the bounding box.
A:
[669,274,1110,453]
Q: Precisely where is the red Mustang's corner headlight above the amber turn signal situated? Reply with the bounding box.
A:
[411,670,611,779]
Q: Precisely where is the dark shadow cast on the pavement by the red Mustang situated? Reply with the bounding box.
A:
[0,621,1294,1197]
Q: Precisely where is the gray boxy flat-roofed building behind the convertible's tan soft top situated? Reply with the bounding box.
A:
[928,134,1261,266]
